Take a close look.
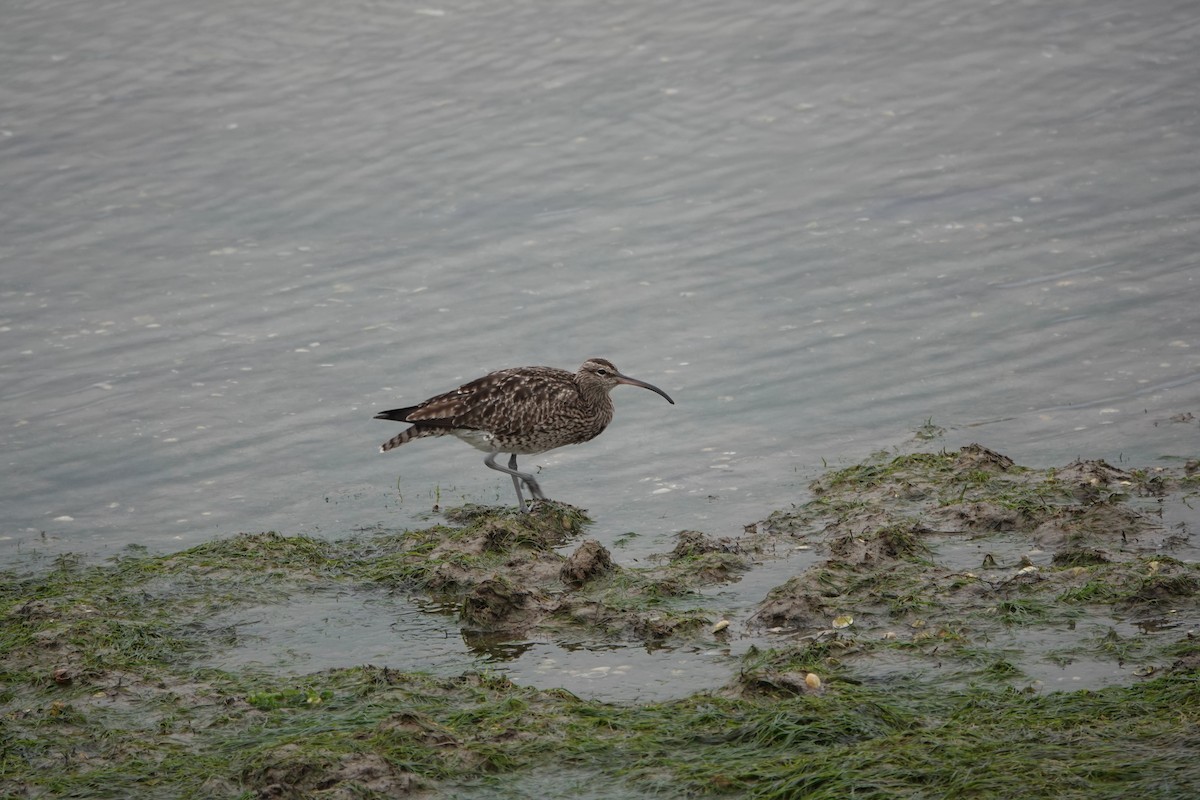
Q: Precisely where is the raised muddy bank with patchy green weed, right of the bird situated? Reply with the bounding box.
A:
[748,445,1200,688]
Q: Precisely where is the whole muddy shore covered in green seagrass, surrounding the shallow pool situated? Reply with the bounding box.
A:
[0,445,1200,800]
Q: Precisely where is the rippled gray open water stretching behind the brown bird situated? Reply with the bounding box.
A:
[0,0,1200,688]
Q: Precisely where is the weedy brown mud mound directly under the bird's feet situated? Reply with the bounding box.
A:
[362,503,750,644]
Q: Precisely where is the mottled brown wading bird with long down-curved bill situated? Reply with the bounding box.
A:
[374,359,674,511]
